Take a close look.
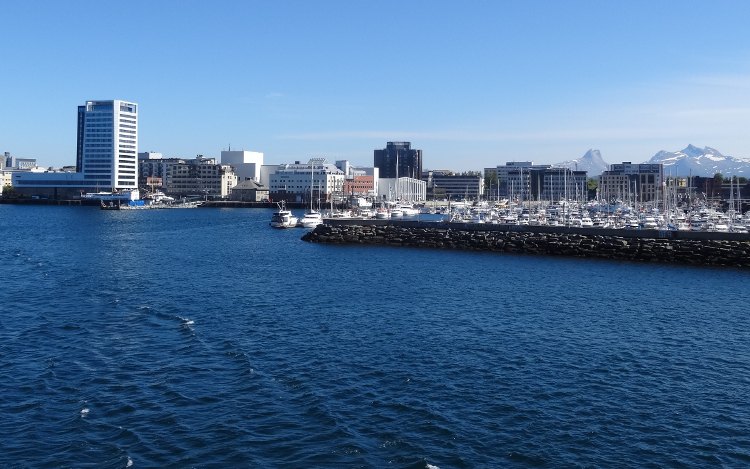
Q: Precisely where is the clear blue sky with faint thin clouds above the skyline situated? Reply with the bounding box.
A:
[0,0,750,170]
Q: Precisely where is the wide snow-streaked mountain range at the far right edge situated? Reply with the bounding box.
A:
[646,145,750,177]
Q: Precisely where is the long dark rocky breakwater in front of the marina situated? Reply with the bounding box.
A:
[302,220,750,268]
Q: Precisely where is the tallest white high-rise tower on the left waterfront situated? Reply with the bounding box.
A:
[76,100,138,190]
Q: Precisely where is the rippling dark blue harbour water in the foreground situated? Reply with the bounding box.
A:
[0,205,750,468]
